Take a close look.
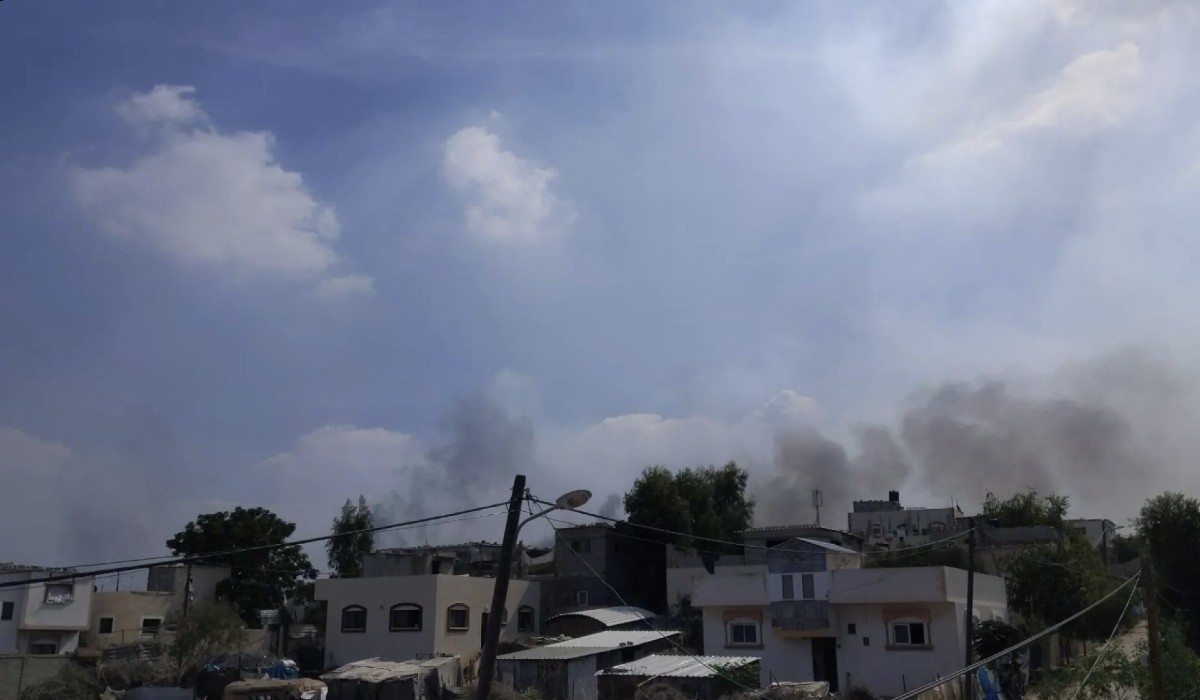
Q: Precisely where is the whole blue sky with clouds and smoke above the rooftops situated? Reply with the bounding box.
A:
[0,0,1200,568]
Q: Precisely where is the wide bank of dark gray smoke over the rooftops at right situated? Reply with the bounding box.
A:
[758,351,1198,523]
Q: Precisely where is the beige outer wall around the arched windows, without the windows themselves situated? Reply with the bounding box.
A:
[316,575,541,671]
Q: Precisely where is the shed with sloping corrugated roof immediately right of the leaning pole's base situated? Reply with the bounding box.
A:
[496,630,679,700]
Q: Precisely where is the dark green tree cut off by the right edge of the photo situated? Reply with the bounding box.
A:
[1135,492,1200,651]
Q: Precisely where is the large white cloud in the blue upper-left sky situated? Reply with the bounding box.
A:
[72,85,365,291]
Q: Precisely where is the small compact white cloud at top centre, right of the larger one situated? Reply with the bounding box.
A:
[442,126,575,244]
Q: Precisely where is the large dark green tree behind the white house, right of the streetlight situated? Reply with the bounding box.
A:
[617,462,754,612]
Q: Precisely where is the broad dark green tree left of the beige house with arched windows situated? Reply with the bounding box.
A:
[167,507,317,626]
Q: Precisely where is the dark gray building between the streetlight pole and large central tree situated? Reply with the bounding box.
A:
[542,522,635,618]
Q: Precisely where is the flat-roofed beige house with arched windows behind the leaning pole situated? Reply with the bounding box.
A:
[316,574,540,675]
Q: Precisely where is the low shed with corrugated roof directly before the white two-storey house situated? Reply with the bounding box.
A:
[596,654,758,700]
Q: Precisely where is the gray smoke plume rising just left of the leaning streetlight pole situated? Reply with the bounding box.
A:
[368,394,534,546]
